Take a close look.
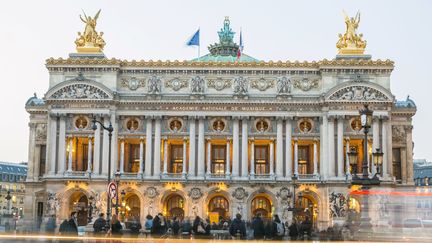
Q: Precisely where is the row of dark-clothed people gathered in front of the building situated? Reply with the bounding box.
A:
[46,212,313,240]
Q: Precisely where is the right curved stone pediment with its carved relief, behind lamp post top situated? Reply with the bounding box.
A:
[324,81,394,103]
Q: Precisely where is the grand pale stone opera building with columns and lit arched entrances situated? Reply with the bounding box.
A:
[26,14,416,229]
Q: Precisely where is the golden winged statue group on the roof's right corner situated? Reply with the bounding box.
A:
[336,11,366,55]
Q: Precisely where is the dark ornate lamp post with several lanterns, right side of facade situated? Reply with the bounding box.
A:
[348,105,383,232]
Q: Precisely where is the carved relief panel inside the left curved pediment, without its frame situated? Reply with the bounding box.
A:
[50,84,109,99]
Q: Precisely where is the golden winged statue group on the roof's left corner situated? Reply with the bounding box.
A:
[75,9,105,53]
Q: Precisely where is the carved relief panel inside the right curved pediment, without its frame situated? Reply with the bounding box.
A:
[329,86,389,101]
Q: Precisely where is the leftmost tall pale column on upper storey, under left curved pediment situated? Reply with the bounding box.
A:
[46,114,57,175]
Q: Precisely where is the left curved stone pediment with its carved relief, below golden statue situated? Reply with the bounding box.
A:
[45,80,114,100]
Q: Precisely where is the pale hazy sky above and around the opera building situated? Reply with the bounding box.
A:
[0,0,432,162]
